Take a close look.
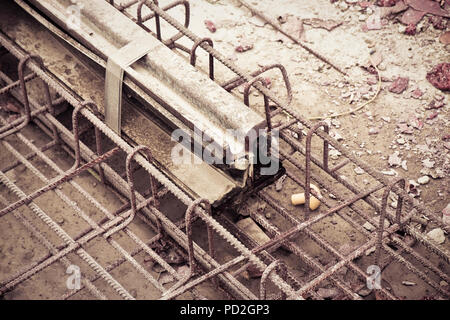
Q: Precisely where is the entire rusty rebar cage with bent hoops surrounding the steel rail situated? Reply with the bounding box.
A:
[0,0,450,299]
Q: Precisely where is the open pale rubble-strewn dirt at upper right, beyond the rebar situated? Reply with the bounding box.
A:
[171,0,450,212]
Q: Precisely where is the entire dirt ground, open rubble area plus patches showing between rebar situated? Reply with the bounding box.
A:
[0,0,450,299]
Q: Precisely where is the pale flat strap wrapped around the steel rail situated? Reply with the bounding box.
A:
[105,35,153,135]
